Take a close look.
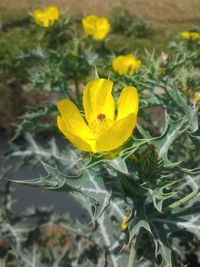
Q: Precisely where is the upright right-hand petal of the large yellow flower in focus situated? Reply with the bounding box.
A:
[117,86,139,120]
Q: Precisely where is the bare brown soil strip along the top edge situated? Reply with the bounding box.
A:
[0,0,200,22]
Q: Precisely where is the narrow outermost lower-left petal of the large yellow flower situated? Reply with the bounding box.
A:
[57,116,92,151]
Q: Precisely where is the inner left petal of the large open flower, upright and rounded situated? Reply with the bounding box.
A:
[57,99,94,139]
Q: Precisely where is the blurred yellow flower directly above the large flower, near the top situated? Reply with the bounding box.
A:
[82,15,110,41]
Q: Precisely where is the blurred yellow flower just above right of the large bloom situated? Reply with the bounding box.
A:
[112,54,141,75]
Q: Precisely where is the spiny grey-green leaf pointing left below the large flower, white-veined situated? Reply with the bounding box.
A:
[7,163,112,221]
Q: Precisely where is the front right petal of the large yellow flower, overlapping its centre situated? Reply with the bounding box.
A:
[96,114,136,152]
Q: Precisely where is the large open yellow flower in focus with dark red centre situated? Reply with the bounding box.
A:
[57,79,138,153]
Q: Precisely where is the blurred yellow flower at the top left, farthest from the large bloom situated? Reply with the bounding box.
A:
[33,6,59,28]
